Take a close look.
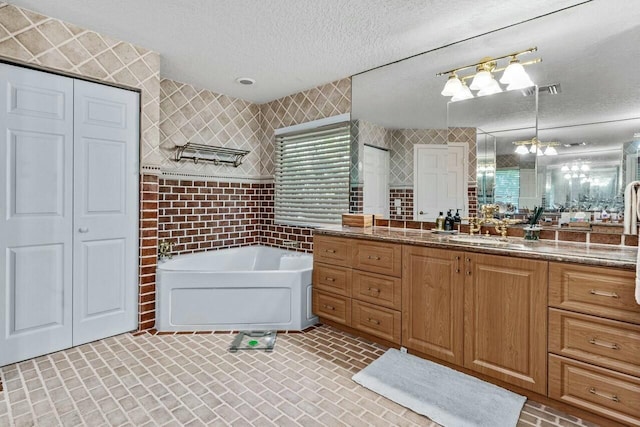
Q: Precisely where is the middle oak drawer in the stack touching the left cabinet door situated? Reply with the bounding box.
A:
[352,270,402,310]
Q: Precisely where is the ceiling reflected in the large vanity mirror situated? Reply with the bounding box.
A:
[352,0,640,157]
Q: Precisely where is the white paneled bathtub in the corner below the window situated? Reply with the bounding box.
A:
[156,246,318,331]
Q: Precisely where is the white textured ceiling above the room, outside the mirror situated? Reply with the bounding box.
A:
[11,0,582,102]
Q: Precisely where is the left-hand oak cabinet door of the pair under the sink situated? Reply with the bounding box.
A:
[402,246,464,365]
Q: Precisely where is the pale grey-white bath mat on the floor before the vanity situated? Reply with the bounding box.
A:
[352,349,527,427]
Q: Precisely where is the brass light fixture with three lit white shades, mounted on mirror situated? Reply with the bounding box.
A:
[436,47,542,102]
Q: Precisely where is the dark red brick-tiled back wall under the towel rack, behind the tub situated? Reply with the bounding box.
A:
[158,179,262,254]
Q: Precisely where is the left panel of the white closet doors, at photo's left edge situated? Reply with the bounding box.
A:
[0,64,73,366]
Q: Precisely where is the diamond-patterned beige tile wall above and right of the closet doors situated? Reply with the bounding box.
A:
[0,3,160,165]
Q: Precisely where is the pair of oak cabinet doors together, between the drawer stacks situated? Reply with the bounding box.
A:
[402,245,547,394]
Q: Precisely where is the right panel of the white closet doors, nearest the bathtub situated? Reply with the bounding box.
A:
[73,80,139,345]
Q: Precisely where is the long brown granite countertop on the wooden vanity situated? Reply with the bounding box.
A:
[315,226,638,270]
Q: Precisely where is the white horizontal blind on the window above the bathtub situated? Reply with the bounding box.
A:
[274,122,351,225]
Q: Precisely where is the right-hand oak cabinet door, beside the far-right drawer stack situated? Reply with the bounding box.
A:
[464,254,548,394]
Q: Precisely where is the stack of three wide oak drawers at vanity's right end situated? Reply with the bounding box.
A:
[549,262,640,426]
